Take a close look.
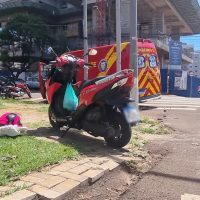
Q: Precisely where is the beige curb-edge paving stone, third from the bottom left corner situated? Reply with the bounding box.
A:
[51,179,80,195]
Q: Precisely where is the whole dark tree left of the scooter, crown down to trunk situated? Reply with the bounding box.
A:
[0,14,53,78]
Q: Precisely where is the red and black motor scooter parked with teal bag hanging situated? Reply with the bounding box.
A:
[39,49,137,148]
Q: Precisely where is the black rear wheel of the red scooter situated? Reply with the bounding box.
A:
[105,111,131,149]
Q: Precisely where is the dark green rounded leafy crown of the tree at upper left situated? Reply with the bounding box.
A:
[0,14,50,48]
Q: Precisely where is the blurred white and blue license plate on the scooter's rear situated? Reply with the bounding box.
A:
[123,105,140,124]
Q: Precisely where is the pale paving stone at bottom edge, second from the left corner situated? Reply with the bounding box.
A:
[29,185,62,200]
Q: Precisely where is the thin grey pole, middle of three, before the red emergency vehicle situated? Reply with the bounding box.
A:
[115,0,121,72]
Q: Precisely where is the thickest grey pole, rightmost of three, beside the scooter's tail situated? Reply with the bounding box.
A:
[130,0,139,110]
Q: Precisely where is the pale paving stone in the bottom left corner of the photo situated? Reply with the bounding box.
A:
[0,190,37,200]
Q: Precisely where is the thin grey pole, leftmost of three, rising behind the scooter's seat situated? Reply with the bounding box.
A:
[83,0,88,80]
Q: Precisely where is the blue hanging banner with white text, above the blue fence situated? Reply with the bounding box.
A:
[169,40,182,66]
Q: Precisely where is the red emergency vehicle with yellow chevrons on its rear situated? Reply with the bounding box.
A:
[68,39,161,100]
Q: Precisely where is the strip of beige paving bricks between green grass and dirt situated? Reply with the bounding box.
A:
[0,157,128,200]
